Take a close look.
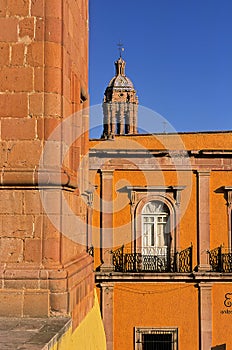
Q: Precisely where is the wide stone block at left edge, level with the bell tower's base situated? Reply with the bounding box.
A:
[1,118,35,140]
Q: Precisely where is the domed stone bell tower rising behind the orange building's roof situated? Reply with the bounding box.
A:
[102,54,138,139]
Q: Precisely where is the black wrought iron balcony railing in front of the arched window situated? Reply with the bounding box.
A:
[112,246,192,272]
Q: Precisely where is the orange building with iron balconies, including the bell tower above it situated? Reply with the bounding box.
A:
[90,57,232,350]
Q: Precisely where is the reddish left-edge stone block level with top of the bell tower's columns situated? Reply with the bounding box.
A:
[0,93,28,118]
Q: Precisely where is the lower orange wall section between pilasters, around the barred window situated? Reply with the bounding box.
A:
[114,283,199,350]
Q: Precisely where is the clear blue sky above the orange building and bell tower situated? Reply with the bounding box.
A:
[89,0,232,135]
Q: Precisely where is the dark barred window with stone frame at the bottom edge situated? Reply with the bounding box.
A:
[135,328,178,350]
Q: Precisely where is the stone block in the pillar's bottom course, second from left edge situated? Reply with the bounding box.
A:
[23,290,50,317]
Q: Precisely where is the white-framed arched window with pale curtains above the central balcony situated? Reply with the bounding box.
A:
[141,201,171,258]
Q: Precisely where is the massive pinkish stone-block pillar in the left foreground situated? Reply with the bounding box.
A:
[0,0,93,325]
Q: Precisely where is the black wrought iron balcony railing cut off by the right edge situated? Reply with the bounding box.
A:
[208,246,232,272]
